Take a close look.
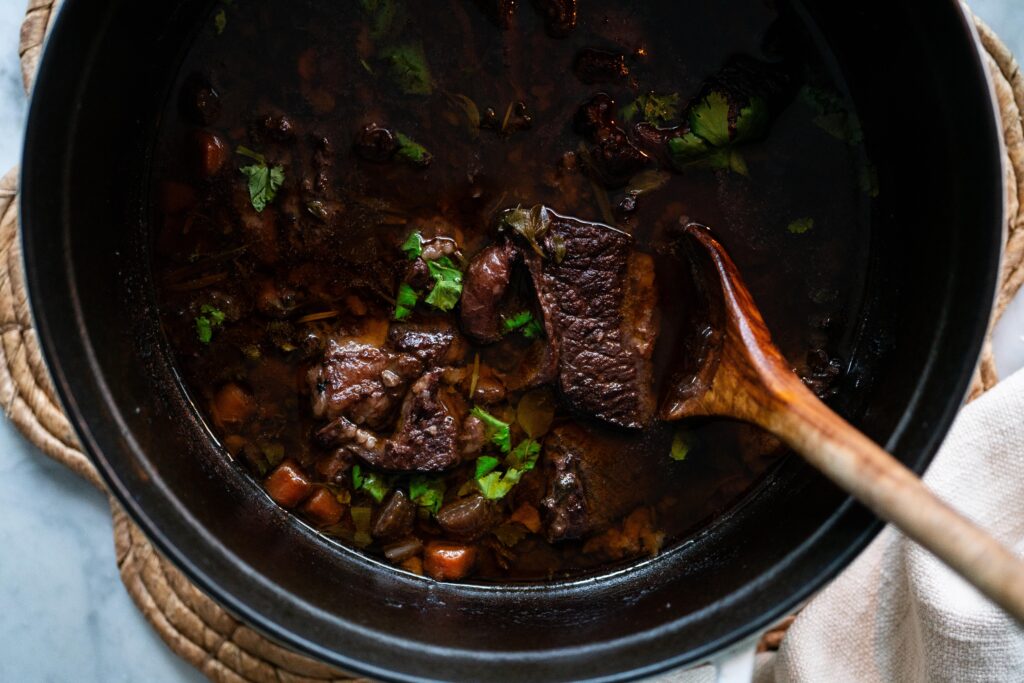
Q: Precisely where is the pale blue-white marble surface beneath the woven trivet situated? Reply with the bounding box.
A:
[0,0,1024,683]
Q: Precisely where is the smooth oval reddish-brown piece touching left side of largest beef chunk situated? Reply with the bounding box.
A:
[461,243,518,344]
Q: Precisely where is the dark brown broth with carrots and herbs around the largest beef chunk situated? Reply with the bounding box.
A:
[153,0,873,580]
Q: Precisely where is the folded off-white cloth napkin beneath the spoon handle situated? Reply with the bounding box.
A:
[755,371,1024,683]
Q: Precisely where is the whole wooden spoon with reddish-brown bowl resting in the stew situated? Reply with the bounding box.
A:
[662,224,1024,625]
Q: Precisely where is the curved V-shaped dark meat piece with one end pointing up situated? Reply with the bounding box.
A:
[316,369,462,472]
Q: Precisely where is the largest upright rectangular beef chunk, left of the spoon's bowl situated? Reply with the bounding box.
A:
[516,209,659,427]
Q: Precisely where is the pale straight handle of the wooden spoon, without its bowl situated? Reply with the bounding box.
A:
[763,389,1024,626]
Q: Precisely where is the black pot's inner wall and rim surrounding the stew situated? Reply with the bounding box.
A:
[22,0,1004,681]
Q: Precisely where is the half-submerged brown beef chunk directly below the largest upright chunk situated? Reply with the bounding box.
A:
[541,424,673,542]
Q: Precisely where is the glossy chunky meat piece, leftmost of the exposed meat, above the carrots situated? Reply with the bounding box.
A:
[308,340,423,429]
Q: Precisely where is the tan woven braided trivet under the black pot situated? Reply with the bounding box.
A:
[8,0,1024,683]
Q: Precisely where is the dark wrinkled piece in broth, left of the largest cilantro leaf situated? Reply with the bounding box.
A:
[574,93,650,187]
